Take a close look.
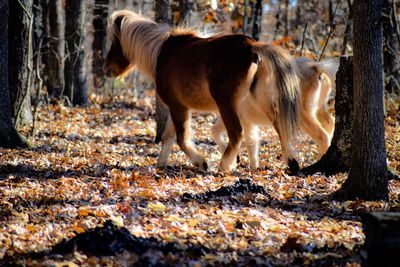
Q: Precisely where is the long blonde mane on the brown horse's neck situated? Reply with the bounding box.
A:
[107,10,198,81]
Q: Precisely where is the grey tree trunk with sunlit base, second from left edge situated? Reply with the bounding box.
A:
[8,0,32,126]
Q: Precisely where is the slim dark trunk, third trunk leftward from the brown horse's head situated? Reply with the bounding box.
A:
[46,0,65,99]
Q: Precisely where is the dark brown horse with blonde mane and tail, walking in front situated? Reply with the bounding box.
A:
[105,10,300,171]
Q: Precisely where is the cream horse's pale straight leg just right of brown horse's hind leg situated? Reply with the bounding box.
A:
[242,123,260,169]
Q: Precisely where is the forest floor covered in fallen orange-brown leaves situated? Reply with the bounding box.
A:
[0,91,400,266]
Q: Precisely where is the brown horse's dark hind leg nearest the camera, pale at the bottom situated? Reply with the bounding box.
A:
[220,107,243,172]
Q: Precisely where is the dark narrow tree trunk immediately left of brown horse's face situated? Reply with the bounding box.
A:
[92,0,110,88]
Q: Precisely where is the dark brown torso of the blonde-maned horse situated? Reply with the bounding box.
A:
[156,34,254,111]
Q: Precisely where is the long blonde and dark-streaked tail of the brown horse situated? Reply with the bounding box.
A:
[253,44,300,148]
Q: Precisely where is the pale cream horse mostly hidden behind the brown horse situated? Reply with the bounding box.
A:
[211,58,338,168]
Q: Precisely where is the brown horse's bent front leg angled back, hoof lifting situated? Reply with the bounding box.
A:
[170,104,208,170]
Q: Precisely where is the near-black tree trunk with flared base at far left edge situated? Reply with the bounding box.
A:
[0,0,28,148]
